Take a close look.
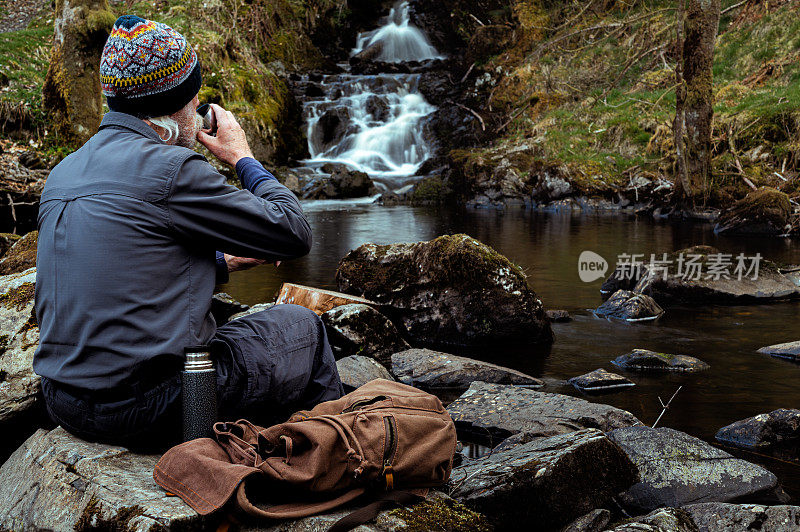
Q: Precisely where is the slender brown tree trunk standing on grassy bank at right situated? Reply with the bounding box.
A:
[683,0,720,201]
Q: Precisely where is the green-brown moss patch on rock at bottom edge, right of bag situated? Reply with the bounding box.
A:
[387,499,492,532]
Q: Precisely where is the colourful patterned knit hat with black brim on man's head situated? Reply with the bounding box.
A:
[100,15,202,118]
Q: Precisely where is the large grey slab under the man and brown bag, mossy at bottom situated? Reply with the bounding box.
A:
[0,427,489,532]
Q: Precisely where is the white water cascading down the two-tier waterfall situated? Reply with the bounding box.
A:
[304,1,441,189]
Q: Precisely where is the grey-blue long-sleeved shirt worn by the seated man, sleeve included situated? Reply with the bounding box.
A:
[33,112,311,390]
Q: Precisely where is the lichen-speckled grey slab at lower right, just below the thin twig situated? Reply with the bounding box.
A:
[608,427,780,511]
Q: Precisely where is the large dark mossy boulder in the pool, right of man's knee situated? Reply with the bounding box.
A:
[336,234,553,347]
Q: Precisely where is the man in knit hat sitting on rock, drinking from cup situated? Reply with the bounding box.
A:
[33,16,343,447]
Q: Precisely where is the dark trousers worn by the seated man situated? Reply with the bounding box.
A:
[42,304,344,451]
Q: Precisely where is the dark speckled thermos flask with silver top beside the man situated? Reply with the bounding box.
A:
[181,345,217,441]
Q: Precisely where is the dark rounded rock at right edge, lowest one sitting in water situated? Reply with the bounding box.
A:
[714,408,800,449]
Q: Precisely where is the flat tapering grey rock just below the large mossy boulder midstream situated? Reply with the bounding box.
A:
[392,349,544,390]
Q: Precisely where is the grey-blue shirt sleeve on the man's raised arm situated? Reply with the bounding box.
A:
[166,154,312,262]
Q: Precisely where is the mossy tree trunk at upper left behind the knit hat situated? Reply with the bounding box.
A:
[42,0,115,144]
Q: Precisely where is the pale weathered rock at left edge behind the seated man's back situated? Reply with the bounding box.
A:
[0,268,41,421]
